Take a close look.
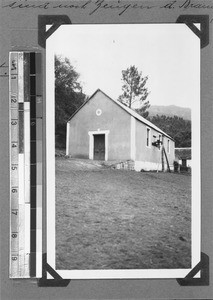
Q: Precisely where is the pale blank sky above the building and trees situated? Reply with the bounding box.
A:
[47,24,200,108]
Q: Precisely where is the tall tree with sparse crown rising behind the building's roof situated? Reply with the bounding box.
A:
[118,66,150,117]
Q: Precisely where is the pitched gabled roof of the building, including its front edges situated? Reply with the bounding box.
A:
[67,89,174,140]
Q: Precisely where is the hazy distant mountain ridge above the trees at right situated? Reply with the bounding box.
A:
[148,105,191,120]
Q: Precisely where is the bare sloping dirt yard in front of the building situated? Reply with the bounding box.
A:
[56,157,191,270]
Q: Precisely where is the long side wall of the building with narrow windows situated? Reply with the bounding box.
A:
[135,120,175,171]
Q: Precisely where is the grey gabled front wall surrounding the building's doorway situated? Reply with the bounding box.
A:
[68,92,131,160]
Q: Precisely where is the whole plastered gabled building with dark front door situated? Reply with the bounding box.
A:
[66,90,175,171]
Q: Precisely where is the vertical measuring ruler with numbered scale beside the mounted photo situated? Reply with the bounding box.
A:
[9,52,42,278]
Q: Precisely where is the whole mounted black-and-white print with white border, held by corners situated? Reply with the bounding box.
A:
[46,23,200,279]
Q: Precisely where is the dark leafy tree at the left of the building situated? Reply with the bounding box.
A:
[55,56,86,148]
